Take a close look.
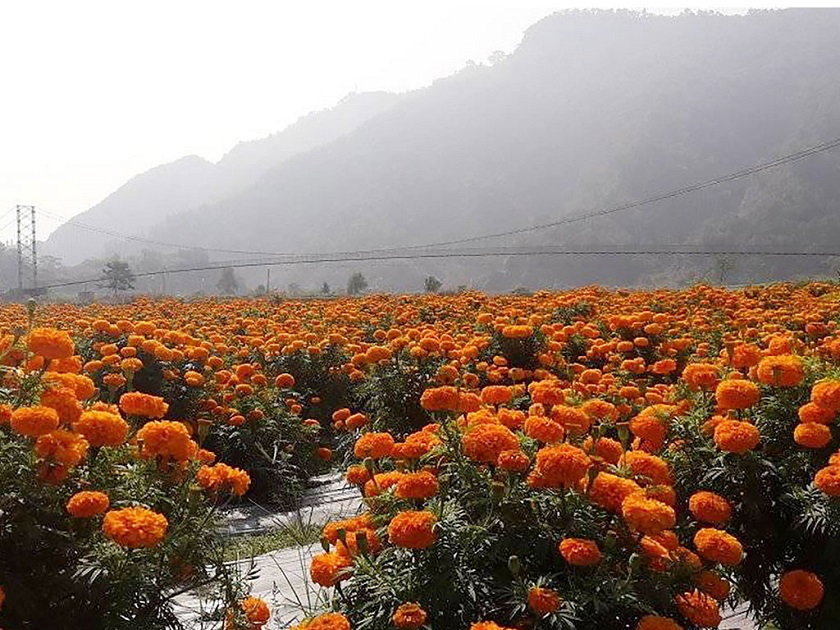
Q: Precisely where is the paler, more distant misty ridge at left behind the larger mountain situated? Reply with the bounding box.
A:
[43,92,400,264]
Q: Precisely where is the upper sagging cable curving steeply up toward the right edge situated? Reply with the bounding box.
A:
[39,138,840,256]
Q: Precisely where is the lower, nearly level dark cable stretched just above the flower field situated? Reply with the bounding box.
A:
[36,248,840,289]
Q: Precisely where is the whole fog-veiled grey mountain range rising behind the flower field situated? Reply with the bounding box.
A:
[42,10,840,290]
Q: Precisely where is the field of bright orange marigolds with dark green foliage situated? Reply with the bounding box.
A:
[0,282,840,630]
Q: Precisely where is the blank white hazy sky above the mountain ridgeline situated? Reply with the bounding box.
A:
[0,0,813,241]
